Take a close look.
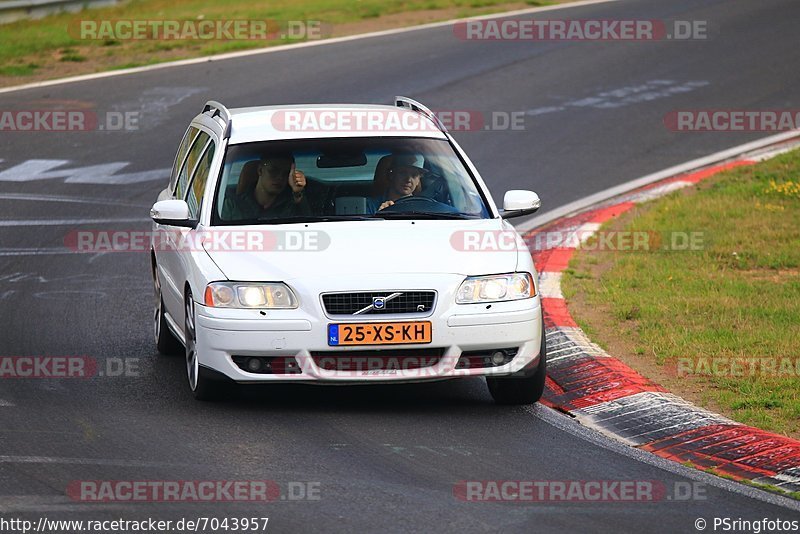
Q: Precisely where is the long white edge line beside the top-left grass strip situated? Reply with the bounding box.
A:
[0,0,617,93]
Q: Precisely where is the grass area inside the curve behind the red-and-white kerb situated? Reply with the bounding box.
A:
[563,150,800,438]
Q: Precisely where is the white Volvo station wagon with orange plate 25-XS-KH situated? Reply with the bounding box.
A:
[150,97,546,404]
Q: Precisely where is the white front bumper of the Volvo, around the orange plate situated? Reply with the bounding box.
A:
[196,296,544,384]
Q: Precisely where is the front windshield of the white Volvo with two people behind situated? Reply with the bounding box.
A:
[212,137,489,225]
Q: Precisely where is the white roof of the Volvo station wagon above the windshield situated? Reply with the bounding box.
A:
[212,104,447,144]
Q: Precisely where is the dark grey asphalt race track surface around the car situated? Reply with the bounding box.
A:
[0,0,800,532]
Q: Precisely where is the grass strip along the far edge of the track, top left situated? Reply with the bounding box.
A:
[0,0,569,86]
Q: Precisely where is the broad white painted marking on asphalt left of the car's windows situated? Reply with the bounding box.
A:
[0,159,170,185]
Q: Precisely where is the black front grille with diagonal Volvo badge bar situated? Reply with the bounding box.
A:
[322,291,436,315]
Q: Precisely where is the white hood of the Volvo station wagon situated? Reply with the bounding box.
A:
[202,219,529,281]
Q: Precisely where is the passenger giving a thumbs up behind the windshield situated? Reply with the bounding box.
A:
[227,153,311,220]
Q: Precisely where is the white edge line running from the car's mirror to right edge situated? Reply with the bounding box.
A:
[514,130,800,232]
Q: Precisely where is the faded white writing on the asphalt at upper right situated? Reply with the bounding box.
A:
[525,80,711,116]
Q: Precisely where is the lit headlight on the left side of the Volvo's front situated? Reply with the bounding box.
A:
[204,282,297,308]
